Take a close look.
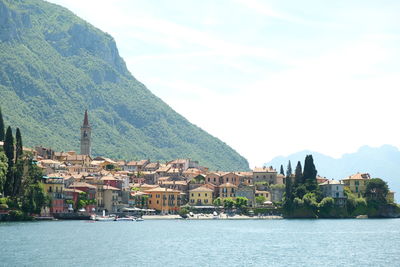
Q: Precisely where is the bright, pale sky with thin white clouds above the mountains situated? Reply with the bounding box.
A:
[50,0,400,168]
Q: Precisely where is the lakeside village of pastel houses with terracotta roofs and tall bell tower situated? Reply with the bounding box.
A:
[18,111,394,218]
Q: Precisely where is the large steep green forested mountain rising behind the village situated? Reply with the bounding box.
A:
[0,0,249,170]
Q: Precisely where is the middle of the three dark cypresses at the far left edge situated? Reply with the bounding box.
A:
[3,126,14,196]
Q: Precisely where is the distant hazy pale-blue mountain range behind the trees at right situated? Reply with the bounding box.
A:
[266,145,400,198]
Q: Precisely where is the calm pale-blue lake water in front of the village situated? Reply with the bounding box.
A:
[0,219,400,266]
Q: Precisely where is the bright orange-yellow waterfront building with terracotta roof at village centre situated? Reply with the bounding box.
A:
[144,187,181,213]
